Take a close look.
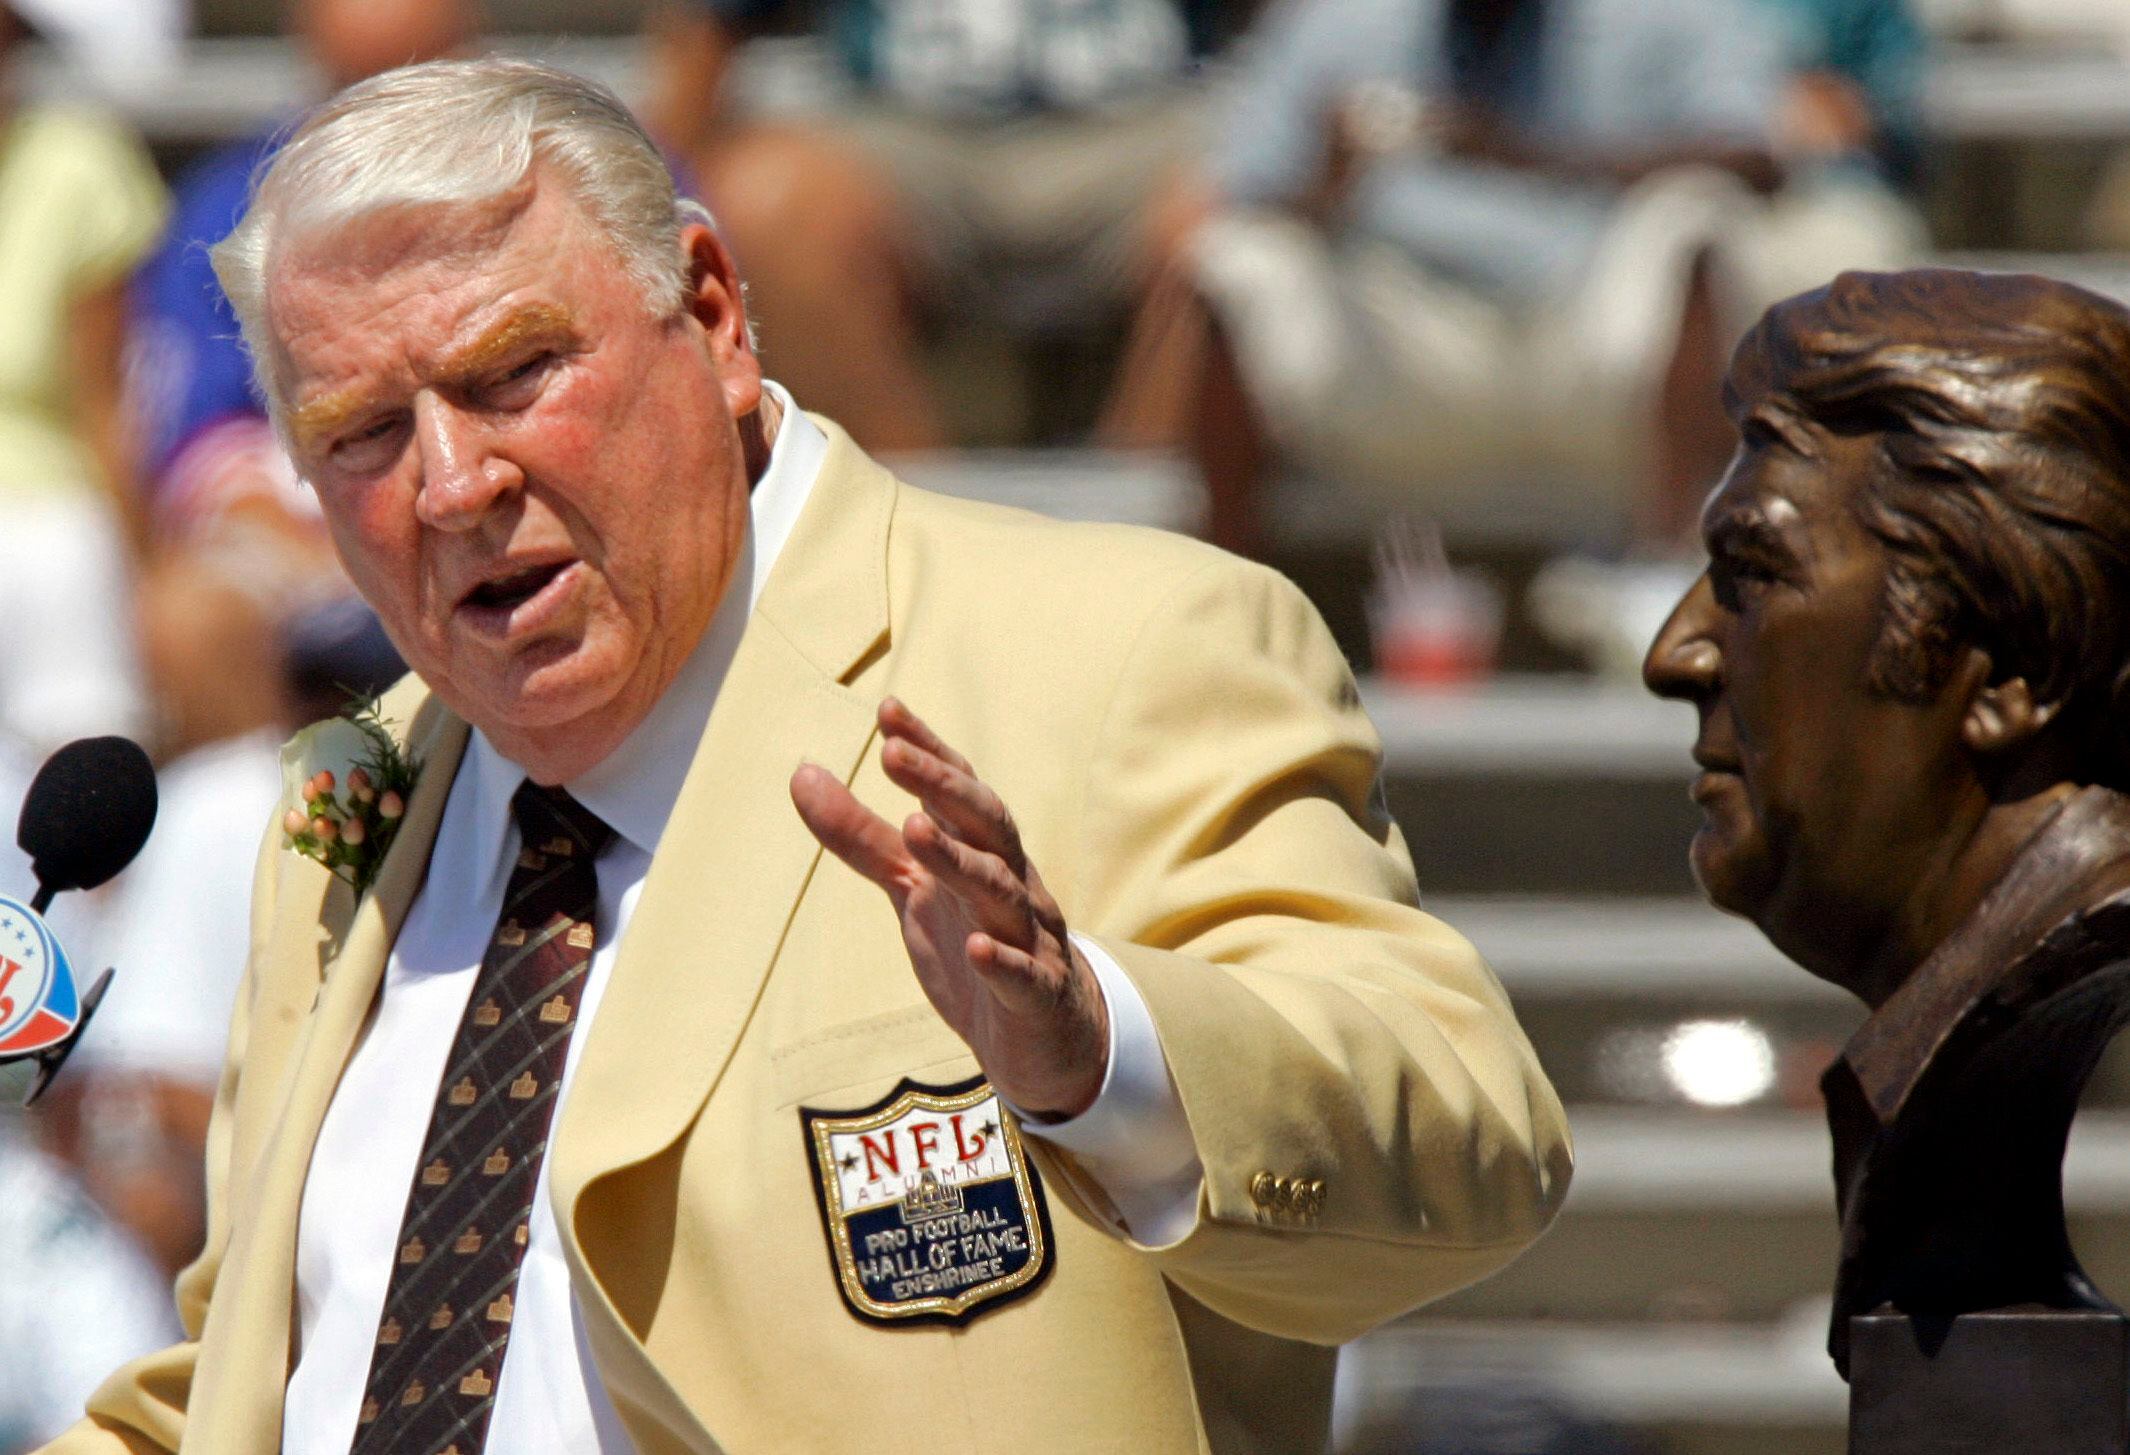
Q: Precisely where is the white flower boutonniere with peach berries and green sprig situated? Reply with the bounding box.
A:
[281,699,422,895]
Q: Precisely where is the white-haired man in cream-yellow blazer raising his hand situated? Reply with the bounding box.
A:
[45,62,1568,1455]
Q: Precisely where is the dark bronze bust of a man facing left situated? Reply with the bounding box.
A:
[1644,271,2130,1374]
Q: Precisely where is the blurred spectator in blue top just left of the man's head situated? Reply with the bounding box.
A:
[132,0,475,766]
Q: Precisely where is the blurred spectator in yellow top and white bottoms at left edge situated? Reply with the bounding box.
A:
[0,0,164,762]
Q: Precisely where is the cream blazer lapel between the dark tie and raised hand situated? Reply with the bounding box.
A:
[550,422,895,1451]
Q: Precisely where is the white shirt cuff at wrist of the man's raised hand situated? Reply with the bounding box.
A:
[1007,935,1206,1248]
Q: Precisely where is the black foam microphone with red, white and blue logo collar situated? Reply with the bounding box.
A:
[0,737,155,1106]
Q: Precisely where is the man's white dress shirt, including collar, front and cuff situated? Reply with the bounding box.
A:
[281,383,1201,1455]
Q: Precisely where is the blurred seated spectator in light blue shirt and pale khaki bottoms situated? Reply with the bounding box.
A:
[1163,0,1906,547]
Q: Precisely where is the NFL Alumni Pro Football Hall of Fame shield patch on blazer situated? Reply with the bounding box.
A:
[799,1078,1056,1325]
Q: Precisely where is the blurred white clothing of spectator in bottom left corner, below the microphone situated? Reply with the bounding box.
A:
[0,1127,183,1455]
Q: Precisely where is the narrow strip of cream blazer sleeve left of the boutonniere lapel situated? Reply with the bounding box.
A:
[40,813,288,1455]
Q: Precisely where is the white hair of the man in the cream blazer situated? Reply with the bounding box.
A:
[211,58,709,424]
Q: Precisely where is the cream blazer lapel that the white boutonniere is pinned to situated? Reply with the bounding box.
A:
[185,692,466,1455]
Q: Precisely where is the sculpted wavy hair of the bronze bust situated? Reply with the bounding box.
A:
[1738,268,2130,788]
